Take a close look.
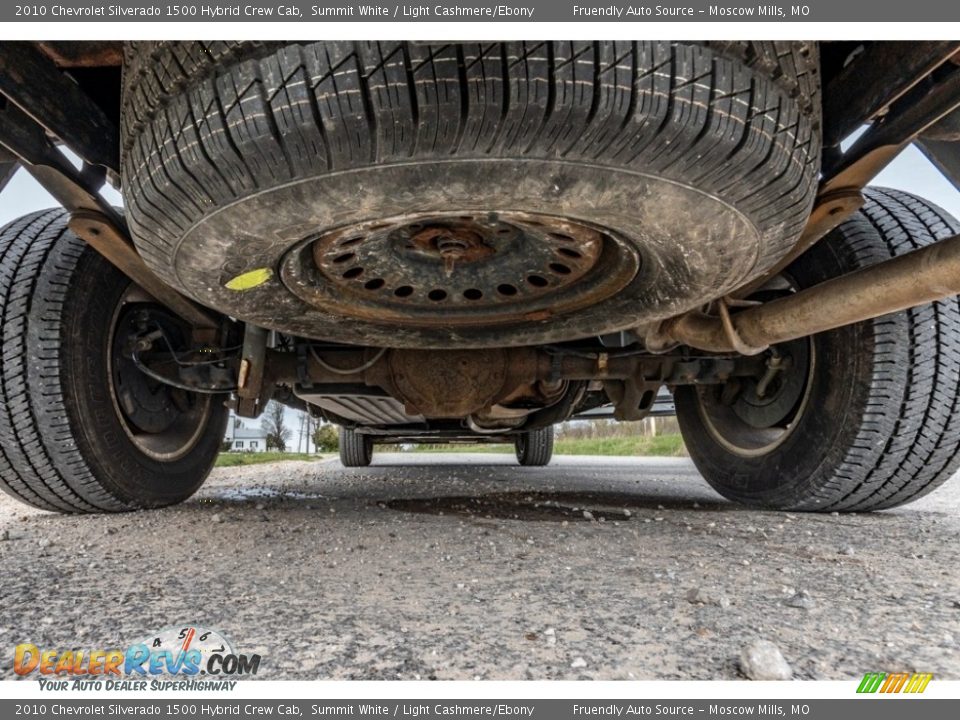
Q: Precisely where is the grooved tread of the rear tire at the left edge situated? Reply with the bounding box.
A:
[0,208,127,512]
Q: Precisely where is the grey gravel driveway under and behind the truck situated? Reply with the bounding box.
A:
[0,454,960,680]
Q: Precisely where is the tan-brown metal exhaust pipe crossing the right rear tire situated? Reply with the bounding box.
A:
[648,235,960,355]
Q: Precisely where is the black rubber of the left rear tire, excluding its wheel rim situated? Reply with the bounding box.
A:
[0,209,227,513]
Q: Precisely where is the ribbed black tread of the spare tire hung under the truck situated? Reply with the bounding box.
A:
[122,41,820,285]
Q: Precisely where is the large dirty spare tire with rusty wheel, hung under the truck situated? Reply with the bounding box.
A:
[122,42,820,347]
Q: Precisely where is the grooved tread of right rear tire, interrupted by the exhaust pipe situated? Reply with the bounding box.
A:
[830,188,960,510]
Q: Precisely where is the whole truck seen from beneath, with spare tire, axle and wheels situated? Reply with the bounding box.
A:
[0,41,960,512]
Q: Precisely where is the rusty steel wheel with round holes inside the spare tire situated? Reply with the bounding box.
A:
[282,212,639,326]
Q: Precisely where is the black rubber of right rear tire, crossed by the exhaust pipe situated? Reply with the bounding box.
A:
[675,189,960,511]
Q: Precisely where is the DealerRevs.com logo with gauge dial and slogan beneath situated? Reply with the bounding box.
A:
[13,626,261,690]
